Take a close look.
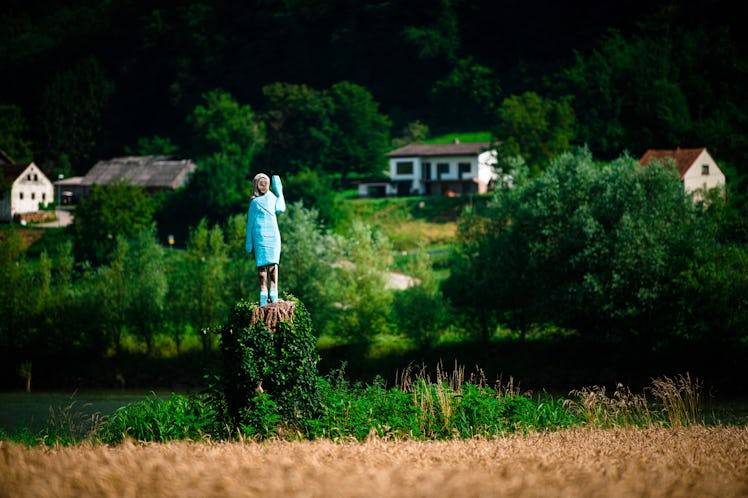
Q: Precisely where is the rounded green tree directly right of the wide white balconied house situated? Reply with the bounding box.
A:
[494,92,575,172]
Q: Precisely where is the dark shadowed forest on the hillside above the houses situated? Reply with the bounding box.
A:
[0,0,748,179]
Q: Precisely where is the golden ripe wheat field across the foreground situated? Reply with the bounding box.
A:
[0,426,748,498]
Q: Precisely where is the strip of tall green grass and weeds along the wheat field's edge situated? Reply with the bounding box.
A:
[0,364,716,444]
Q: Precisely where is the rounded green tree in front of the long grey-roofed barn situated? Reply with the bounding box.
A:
[72,181,155,265]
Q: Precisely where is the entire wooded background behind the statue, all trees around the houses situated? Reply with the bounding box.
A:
[0,0,748,392]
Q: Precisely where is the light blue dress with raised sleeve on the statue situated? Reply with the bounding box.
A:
[246,175,286,268]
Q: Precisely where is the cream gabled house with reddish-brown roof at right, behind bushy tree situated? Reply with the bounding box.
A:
[639,147,725,199]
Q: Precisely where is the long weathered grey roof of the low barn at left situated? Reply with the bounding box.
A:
[80,156,196,189]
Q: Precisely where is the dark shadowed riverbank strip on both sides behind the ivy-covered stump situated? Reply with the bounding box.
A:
[0,339,748,399]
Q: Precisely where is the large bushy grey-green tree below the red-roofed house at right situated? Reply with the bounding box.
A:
[445,146,728,345]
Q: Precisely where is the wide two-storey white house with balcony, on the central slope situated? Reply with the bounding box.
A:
[359,140,498,197]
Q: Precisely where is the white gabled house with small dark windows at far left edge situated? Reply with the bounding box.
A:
[0,153,54,221]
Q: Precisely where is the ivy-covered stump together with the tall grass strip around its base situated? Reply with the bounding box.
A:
[0,296,724,444]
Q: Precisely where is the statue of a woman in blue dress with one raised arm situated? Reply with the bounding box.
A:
[246,173,286,306]
